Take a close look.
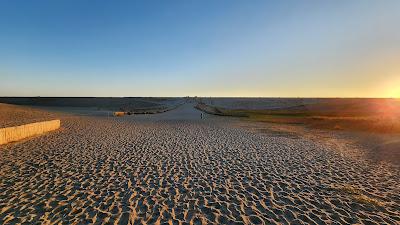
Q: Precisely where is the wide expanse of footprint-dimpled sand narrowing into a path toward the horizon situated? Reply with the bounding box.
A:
[0,104,400,224]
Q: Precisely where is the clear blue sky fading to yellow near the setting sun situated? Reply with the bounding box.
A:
[0,0,400,97]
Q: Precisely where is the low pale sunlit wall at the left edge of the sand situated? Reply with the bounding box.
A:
[0,120,61,145]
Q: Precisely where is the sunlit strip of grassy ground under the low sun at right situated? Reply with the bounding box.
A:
[197,100,400,133]
